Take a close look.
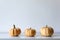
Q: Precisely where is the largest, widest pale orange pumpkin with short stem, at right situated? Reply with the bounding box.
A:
[40,25,54,37]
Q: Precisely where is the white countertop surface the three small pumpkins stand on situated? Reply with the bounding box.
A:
[0,32,60,40]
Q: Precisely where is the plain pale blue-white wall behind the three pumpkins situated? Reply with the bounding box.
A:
[0,0,60,32]
